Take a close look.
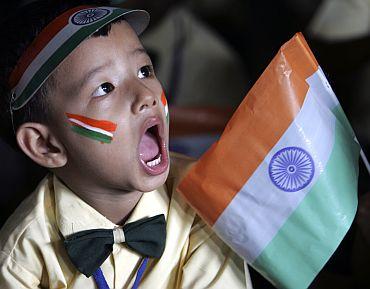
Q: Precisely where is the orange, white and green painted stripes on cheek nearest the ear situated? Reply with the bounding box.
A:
[66,113,117,143]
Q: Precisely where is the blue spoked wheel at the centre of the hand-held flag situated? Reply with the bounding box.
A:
[269,147,315,192]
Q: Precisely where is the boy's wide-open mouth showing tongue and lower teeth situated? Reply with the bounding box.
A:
[139,118,168,175]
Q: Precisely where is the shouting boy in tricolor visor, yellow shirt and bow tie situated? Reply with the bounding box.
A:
[0,1,248,289]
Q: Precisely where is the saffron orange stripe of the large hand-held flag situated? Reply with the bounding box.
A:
[179,34,318,226]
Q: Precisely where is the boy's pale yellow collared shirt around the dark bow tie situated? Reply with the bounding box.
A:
[0,155,249,289]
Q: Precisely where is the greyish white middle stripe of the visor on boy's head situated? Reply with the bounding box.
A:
[15,7,114,97]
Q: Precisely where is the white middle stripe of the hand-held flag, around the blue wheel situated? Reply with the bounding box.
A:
[214,71,336,263]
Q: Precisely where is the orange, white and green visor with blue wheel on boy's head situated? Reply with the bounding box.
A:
[9,6,149,110]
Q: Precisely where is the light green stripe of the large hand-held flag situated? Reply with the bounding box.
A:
[252,108,359,289]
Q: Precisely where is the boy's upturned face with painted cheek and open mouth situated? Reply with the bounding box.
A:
[50,21,169,193]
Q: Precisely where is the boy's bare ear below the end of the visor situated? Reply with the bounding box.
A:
[16,122,67,168]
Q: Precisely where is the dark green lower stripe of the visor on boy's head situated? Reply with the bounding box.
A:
[13,8,127,109]
